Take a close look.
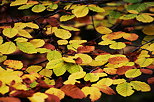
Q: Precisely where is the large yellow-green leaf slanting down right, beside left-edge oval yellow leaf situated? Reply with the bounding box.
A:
[16,42,37,54]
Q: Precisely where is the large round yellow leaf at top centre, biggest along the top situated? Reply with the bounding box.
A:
[72,5,89,17]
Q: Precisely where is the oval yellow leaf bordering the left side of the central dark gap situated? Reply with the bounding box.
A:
[54,29,72,39]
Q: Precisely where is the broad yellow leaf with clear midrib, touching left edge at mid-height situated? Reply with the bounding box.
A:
[0,42,16,54]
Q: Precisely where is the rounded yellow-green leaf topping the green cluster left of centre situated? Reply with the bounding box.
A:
[47,50,62,61]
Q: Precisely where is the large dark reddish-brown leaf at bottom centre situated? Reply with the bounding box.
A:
[61,84,85,99]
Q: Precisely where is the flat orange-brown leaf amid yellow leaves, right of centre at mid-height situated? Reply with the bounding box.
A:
[109,57,129,64]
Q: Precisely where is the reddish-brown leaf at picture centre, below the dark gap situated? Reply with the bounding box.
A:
[77,46,95,53]
